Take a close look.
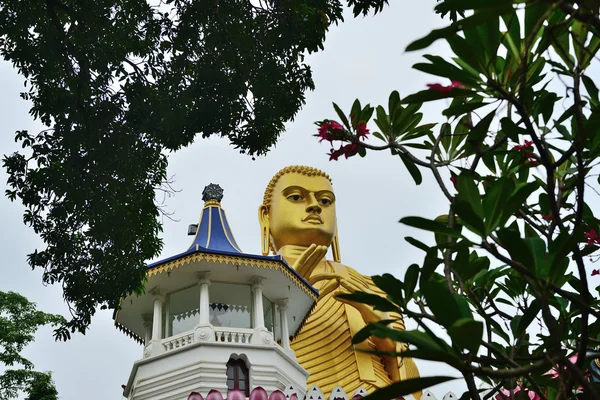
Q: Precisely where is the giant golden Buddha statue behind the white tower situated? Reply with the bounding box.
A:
[258,166,421,399]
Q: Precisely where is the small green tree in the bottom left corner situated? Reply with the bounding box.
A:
[0,291,65,400]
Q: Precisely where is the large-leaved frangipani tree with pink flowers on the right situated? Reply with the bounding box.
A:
[315,0,600,400]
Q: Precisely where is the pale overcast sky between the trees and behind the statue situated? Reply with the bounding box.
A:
[0,0,474,400]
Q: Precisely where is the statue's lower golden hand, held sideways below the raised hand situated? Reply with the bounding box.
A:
[308,273,389,324]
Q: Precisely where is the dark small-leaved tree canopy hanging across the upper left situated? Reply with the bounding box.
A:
[0,0,386,338]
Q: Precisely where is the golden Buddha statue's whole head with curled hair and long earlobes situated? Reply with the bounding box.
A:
[258,165,339,261]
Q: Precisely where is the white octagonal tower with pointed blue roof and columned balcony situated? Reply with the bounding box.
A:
[114,184,318,400]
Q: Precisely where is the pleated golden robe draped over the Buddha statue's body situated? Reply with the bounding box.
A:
[291,262,421,399]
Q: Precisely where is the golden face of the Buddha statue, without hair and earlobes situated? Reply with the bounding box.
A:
[262,172,337,249]
